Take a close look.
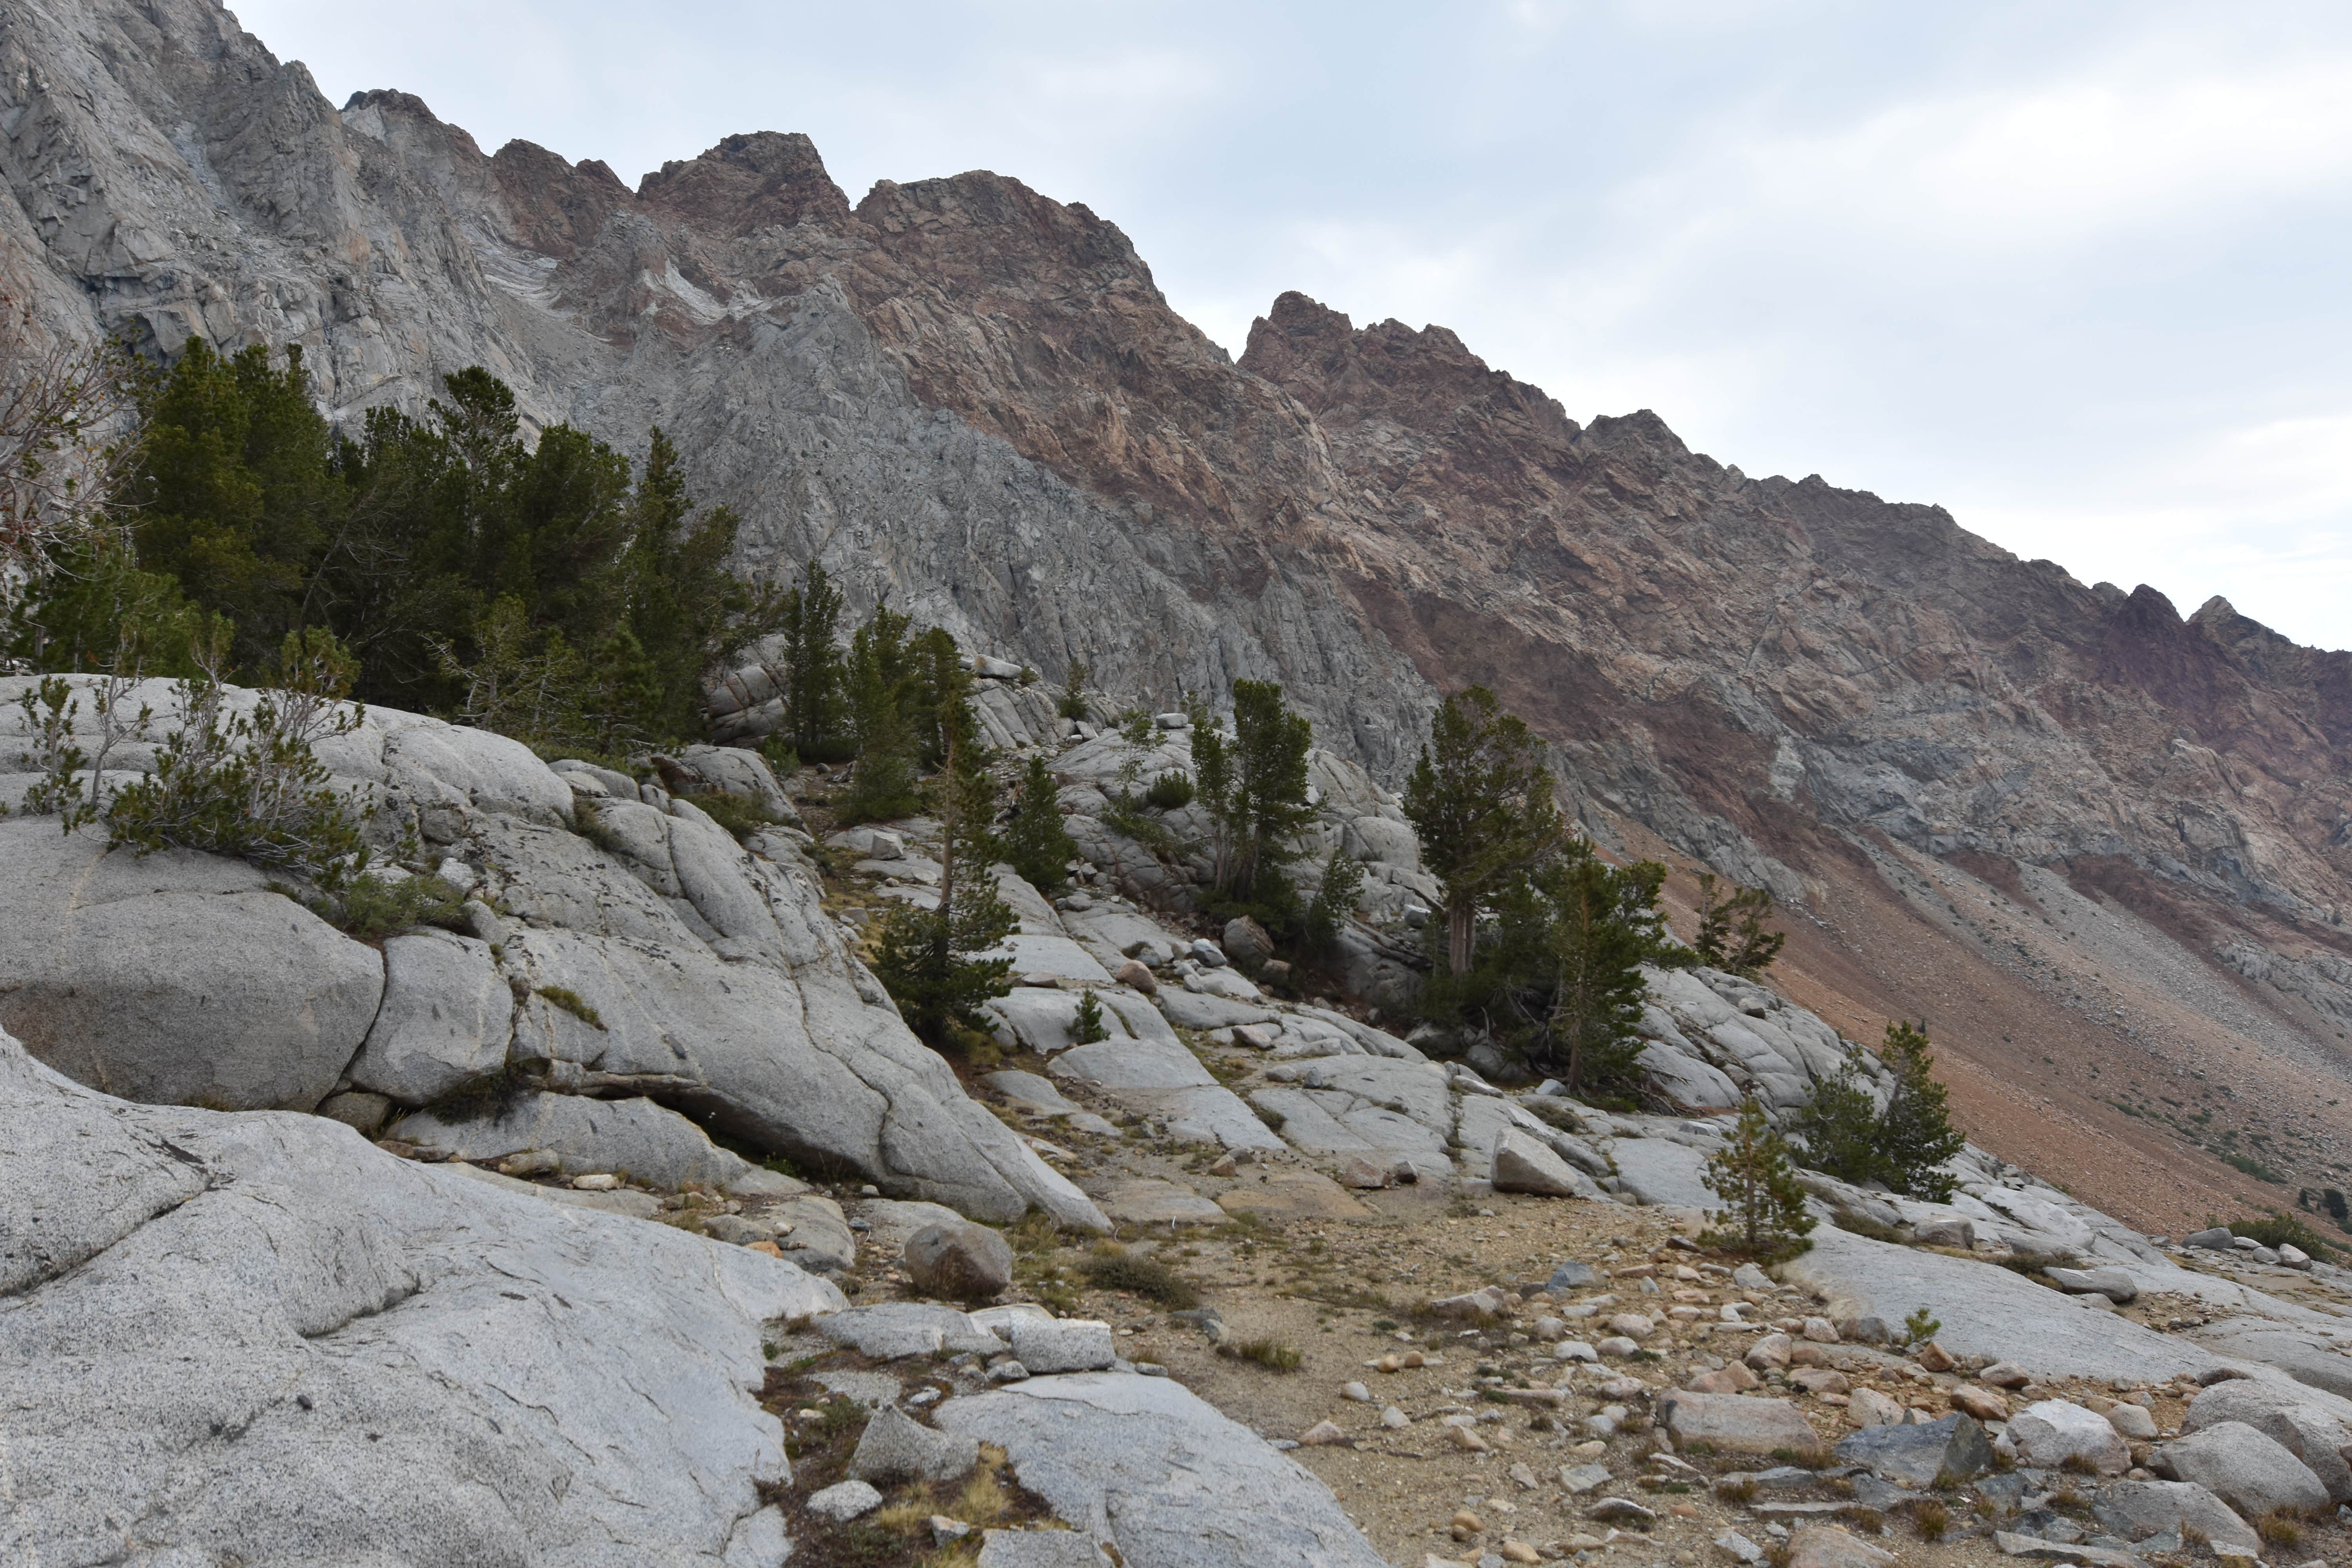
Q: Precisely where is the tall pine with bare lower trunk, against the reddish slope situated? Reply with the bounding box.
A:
[1404,686,1566,976]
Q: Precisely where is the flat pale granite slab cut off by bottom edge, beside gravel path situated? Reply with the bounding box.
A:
[938,1373,1383,1568]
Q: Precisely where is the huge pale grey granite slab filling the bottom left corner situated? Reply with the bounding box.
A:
[0,1037,842,1568]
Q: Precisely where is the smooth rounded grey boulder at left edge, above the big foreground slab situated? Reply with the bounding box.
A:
[0,822,383,1110]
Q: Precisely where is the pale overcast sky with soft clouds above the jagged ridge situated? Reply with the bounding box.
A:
[233,0,2352,649]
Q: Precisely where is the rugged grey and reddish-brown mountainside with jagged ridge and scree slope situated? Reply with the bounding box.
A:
[14,0,2352,1229]
